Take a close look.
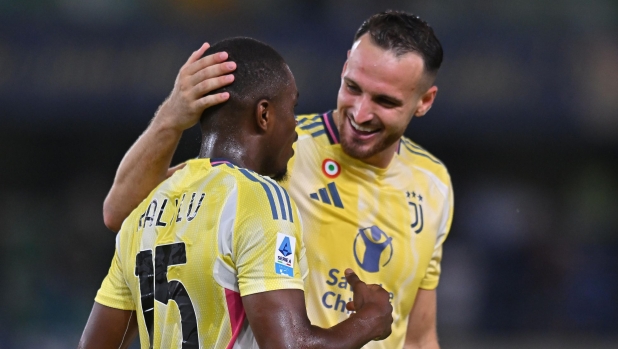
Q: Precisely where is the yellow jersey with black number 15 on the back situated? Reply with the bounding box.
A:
[95,159,307,349]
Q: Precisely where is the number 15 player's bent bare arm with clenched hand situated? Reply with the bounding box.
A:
[243,269,393,349]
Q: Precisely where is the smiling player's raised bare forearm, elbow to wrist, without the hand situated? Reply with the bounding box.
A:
[103,102,182,231]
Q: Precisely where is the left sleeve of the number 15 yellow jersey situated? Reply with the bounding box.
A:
[94,250,135,310]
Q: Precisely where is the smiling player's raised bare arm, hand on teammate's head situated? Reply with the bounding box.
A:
[103,44,236,232]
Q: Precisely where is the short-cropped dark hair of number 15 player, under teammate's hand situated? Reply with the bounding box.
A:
[202,37,290,120]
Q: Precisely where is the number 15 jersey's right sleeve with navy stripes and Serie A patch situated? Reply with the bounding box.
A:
[233,175,306,296]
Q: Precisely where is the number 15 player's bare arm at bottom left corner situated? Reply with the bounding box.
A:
[77,302,138,349]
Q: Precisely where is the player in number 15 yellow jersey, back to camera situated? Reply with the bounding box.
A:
[80,38,392,348]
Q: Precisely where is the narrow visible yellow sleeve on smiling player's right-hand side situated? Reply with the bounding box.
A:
[420,180,453,290]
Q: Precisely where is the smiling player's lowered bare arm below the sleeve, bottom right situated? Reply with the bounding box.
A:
[404,289,440,349]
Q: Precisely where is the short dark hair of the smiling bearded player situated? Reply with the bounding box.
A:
[354,10,443,76]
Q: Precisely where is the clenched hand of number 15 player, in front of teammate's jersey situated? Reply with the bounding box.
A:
[345,269,393,340]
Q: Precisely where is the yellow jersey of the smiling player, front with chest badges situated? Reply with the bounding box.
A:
[285,112,453,349]
